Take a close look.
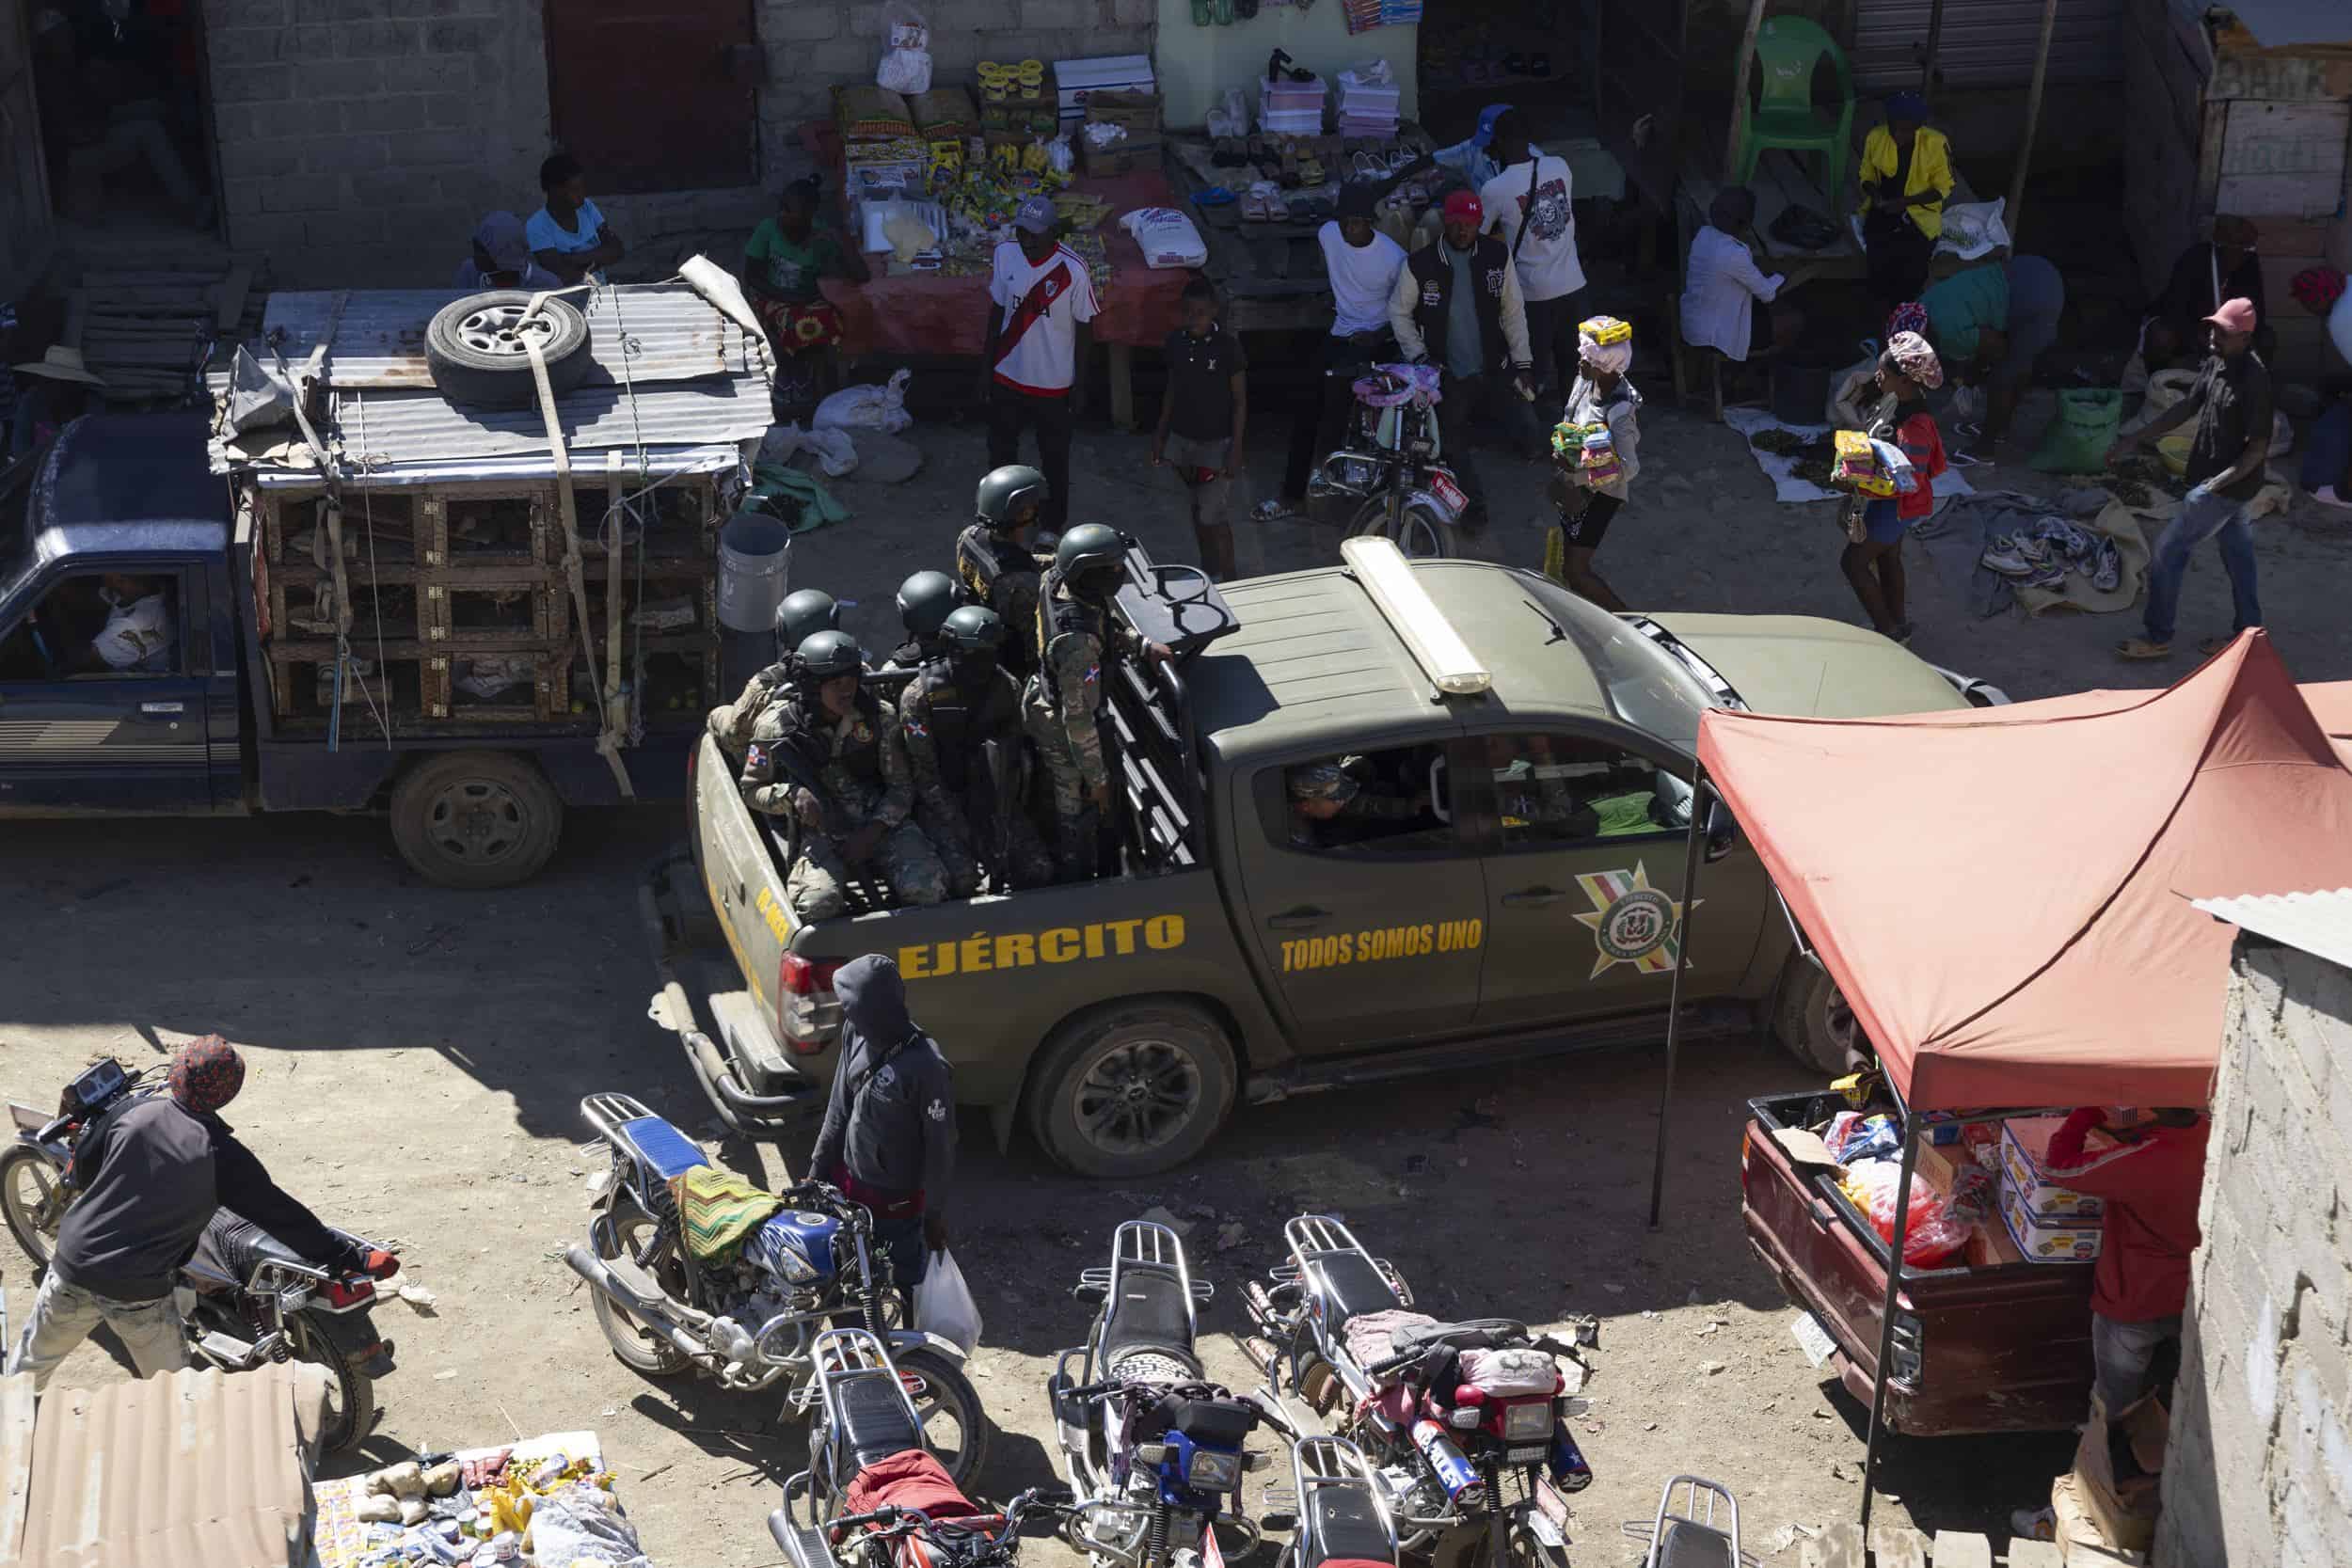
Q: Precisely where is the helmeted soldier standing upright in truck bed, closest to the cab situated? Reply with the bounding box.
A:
[1024,522,1169,881]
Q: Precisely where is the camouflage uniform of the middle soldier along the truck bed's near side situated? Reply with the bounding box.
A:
[898,658,1054,898]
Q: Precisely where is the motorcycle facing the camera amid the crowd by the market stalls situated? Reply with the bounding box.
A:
[1308,364,1470,560]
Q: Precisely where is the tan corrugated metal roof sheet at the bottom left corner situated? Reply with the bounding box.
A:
[24,1366,325,1568]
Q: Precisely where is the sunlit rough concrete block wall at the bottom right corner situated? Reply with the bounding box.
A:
[2157,941,2352,1568]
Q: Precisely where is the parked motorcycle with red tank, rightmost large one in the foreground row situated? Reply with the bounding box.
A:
[1242,1215,1593,1568]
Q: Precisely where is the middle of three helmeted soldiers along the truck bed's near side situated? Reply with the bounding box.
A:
[898,604,1054,898]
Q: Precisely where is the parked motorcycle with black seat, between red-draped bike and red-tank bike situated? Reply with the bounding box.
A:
[1047,1220,1263,1568]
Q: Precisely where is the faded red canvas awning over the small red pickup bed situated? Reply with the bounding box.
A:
[1698,630,2352,1110]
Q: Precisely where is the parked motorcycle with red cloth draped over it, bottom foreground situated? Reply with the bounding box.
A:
[767,1328,1066,1568]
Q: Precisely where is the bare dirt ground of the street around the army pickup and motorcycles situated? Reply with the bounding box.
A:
[0,390,2352,1568]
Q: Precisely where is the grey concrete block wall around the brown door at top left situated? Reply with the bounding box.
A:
[205,0,1155,287]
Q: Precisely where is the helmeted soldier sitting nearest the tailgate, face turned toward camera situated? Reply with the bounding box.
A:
[741,632,948,919]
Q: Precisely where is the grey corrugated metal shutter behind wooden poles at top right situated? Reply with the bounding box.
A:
[1851,0,2124,91]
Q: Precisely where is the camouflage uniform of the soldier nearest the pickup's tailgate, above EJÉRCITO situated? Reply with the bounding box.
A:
[741,689,948,919]
